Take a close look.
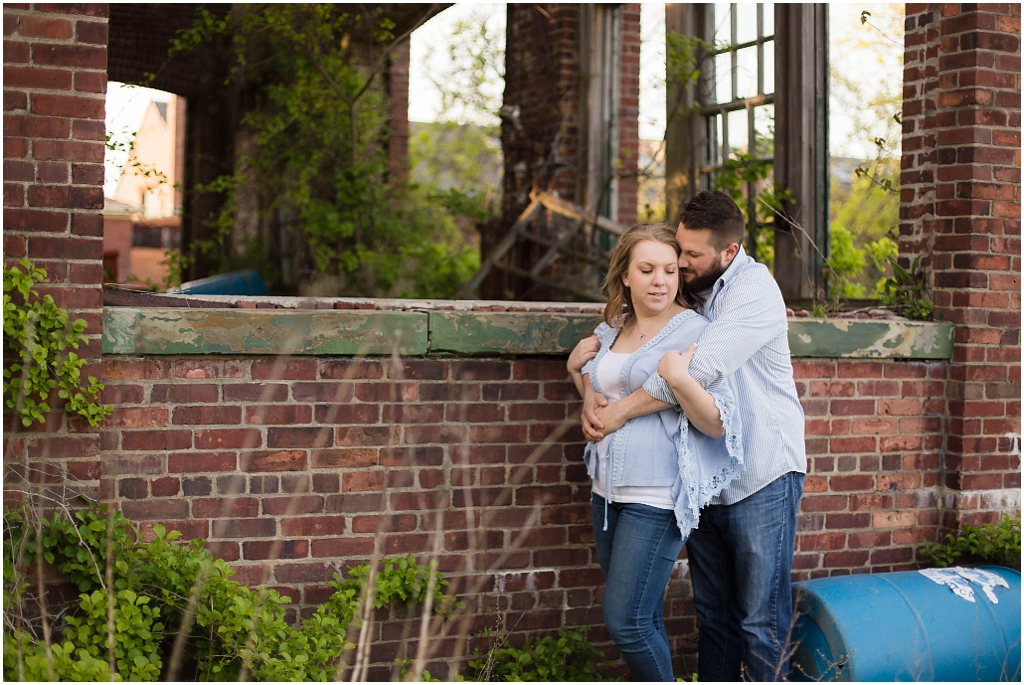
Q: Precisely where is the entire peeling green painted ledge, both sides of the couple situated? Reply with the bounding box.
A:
[103,307,952,359]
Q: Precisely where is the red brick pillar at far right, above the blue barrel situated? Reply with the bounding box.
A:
[900,4,1021,527]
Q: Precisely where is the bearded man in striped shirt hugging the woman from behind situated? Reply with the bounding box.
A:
[583,191,807,682]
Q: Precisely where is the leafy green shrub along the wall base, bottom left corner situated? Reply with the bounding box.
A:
[3,507,452,681]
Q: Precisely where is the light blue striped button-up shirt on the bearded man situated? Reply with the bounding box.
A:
[643,248,807,504]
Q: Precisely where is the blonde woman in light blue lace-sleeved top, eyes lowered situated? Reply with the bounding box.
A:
[567,224,742,681]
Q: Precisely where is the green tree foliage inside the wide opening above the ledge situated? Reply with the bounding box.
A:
[169,4,479,297]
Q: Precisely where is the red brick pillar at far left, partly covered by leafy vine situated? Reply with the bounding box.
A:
[3,4,108,501]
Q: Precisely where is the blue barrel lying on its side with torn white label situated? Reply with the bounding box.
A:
[790,566,1021,682]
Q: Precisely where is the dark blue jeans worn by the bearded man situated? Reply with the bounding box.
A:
[686,472,804,682]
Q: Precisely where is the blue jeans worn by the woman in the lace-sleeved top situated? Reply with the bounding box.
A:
[591,495,683,682]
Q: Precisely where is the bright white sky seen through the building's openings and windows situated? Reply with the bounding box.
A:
[104,3,902,195]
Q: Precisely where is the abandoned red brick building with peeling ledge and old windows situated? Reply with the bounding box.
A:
[3,3,1021,680]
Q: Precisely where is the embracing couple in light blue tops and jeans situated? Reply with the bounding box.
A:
[567,191,806,682]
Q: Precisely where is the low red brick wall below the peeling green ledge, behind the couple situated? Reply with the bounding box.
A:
[2,356,946,675]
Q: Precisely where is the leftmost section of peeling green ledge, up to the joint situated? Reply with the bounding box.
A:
[103,307,429,356]
